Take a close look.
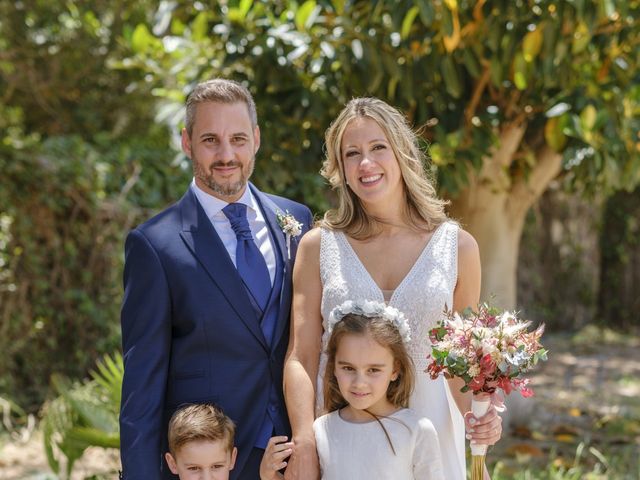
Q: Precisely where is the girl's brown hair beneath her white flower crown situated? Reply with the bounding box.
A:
[323,313,415,412]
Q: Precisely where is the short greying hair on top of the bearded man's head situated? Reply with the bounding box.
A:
[185,78,258,138]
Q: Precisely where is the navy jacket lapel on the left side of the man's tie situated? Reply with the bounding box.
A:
[180,189,269,350]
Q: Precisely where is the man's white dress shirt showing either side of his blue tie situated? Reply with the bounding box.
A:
[191,178,276,285]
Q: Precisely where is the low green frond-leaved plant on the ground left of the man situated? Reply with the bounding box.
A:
[42,353,124,478]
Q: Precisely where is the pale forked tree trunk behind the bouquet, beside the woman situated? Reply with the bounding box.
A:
[449,124,562,309]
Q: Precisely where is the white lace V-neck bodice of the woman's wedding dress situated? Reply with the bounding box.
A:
[320,222,458,372]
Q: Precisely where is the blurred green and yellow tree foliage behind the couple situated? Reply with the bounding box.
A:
[0,0,640,411]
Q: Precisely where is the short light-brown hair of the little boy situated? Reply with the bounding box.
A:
[169,403,236,457]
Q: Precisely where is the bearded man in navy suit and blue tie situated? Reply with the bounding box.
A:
[120,79,312,480]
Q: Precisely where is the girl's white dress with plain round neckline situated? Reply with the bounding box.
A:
[313,408,445,480]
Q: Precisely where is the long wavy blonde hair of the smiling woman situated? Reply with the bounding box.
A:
[320,97,447,239]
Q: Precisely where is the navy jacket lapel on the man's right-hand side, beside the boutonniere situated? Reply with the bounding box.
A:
[249,183,293,347]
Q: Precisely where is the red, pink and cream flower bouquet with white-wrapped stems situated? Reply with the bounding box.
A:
[426,304,547,480]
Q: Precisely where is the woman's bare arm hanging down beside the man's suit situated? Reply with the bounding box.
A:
[284,229,322,480]
